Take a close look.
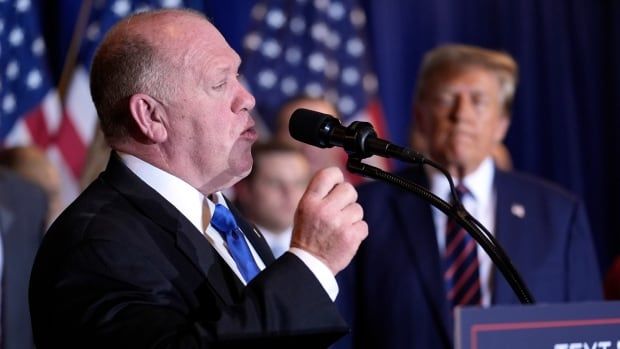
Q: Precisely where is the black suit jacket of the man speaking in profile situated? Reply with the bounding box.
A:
[30,154,346,349]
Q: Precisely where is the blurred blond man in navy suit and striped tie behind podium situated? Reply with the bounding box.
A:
[339,45,602,349]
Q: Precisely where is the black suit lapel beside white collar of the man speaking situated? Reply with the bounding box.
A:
[100,153,243,304]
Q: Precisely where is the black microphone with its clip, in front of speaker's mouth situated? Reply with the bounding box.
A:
[288,108,425,164]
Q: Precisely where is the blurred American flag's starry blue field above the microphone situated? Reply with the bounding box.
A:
[242,0,385,141]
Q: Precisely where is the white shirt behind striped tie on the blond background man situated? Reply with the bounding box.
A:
[428,157,497,307]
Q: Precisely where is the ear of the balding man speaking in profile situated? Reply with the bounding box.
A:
[129,93,168,143]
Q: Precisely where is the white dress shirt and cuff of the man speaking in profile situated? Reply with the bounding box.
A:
[118,152,338,301]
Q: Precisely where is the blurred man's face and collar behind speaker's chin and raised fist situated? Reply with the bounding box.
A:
[235,141,311,258]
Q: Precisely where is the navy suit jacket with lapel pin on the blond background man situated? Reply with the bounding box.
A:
[336,169,602,349]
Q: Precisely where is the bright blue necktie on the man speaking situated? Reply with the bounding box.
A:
[211,204,260,282]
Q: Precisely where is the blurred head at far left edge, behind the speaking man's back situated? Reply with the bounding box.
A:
[0,145,63,226]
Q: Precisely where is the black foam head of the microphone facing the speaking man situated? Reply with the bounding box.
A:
[288,108,340,148]
